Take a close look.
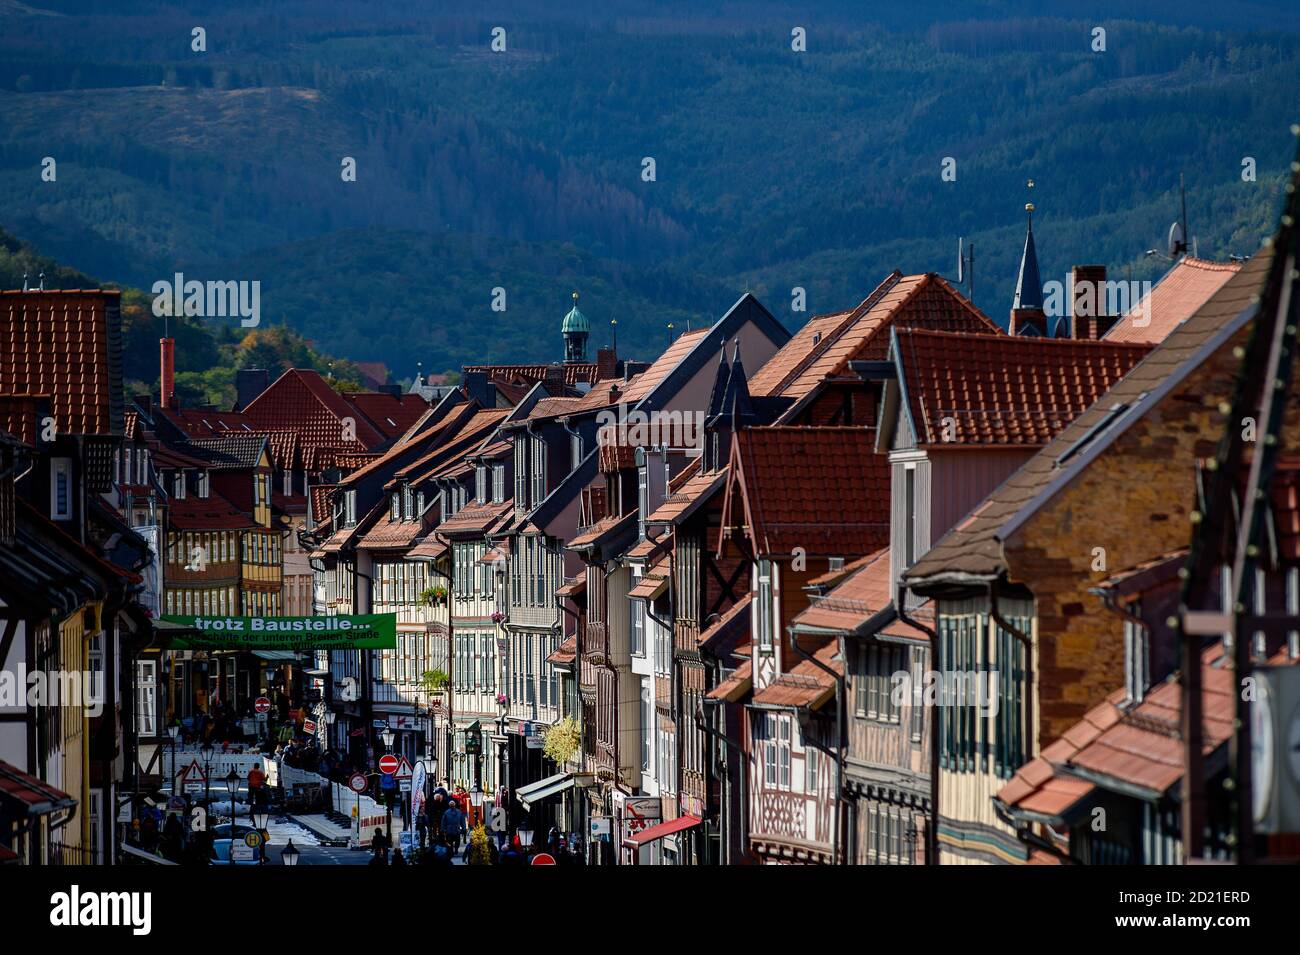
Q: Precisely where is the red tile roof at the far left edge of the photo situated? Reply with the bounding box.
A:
[0,290,125,434]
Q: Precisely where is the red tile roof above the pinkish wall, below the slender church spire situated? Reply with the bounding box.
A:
[892,329,1151,448]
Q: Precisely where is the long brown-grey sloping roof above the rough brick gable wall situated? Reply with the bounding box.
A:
[906,248,1273,582]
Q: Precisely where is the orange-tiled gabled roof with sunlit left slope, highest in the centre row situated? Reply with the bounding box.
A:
[749,272,1002,399]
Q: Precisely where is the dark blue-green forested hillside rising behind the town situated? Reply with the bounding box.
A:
[0,0,1300,377]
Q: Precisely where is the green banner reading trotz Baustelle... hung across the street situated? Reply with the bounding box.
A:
[163,613,398,650]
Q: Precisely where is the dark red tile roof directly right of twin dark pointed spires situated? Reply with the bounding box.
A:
[724,426,889,557]
